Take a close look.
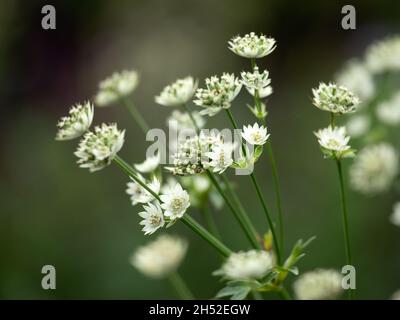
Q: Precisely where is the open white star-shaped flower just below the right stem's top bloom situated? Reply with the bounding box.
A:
[314,126,350,157]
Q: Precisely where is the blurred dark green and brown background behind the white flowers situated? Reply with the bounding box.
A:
[0,0,400,299]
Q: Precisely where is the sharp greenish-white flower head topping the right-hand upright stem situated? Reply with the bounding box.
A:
[312,83,360,114]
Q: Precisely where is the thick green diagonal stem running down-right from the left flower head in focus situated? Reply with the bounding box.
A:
[113,155,232,257]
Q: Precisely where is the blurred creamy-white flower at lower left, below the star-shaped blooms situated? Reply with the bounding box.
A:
[130,235,188,279]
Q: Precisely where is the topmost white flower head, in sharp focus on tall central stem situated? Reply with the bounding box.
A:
[228,32,276,58]
